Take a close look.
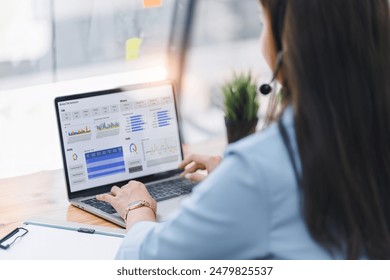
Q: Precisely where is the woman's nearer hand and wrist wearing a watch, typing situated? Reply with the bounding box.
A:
[96,181,157,229]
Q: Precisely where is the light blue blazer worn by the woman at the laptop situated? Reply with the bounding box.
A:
[117,107,338,259]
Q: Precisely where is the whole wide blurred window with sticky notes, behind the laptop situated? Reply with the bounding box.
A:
[0,0,176,89]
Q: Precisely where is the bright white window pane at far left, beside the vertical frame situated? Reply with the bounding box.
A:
[0,0,53,89]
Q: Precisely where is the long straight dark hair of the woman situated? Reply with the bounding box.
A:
[261,0,390,259]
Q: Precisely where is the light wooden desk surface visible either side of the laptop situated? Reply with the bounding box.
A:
[0,139,226,238]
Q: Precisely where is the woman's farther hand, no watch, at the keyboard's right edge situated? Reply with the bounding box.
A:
[179,155,222,182]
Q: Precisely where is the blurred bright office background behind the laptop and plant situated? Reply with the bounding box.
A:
[0,0,271,178]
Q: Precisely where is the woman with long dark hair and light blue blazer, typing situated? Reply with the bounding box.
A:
[99,0,390,259]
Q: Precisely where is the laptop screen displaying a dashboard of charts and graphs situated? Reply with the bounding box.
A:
[57,83,182,192]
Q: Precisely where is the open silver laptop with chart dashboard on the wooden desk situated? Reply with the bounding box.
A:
[55,81,194,227]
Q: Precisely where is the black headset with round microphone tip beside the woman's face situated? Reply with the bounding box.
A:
[259,0,287,95]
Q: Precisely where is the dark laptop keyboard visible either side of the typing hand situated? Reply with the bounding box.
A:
[82,178,196,214]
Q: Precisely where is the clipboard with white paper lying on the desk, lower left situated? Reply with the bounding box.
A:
[0,218,126,260]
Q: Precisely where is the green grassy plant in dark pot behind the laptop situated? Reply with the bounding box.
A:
[222,73,260,144]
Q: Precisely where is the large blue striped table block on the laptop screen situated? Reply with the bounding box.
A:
[85,147,126,179]
